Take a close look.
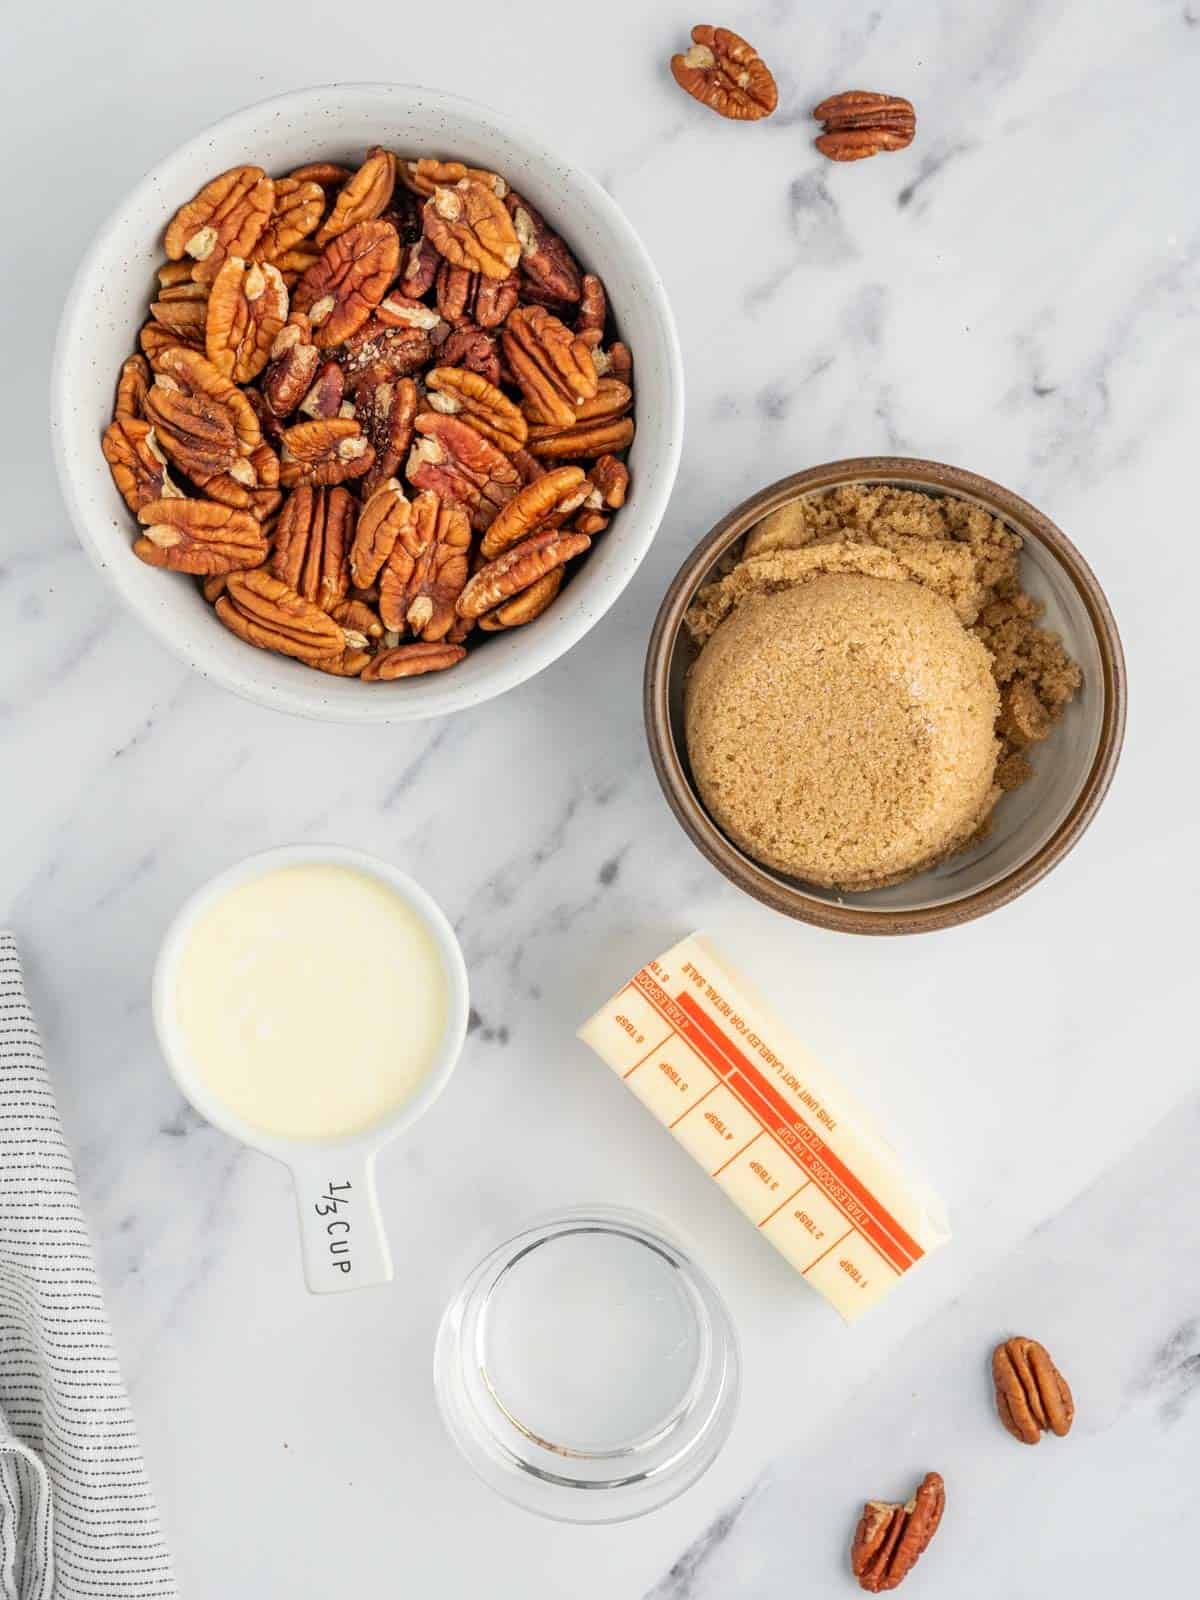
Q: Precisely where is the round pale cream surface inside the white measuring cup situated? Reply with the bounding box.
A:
[174,862,448,1139]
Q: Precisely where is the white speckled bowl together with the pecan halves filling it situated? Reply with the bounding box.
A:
[51,85,683,722]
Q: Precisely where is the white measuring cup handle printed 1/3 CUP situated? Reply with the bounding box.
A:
[291,1150,392,1294]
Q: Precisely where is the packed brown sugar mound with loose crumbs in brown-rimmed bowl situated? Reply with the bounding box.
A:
[686,485,1080,890]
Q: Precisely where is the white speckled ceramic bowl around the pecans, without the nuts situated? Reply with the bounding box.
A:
[51,83,683,722]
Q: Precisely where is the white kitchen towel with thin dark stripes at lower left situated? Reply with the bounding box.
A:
[0,933,178,1600]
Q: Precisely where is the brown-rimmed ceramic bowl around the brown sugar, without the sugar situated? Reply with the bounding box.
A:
[645,456,1125,933]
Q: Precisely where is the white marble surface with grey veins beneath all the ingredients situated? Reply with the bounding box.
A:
[0,0,1200,1600]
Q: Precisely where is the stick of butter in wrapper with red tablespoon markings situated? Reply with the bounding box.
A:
[579,934,950,1322]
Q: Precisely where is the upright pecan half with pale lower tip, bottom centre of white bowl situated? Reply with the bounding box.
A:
[379,491,470,643]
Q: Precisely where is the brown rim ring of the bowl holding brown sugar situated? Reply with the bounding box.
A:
[643,456,1126,934]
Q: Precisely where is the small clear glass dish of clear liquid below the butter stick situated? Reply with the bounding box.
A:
[434,1206,741,1523]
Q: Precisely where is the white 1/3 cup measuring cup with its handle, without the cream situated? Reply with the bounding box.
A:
[152,845,469,1294]
